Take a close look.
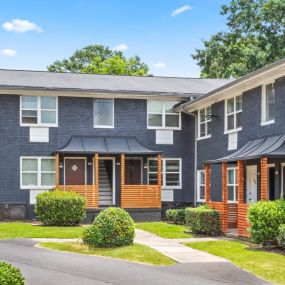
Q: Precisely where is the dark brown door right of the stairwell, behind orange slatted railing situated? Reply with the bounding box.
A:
[125,159,142,185]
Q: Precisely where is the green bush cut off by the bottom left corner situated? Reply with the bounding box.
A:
[0,262,25,285]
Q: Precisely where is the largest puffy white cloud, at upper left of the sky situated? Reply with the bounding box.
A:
[2,19,43,33]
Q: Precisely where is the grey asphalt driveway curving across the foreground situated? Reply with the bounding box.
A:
[0,239,269,285]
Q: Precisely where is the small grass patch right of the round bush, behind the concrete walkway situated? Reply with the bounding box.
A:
[136,222,192,239]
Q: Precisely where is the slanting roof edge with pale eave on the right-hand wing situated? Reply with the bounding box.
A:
[176,58,285,111]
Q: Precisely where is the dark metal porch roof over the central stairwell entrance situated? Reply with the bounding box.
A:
[57,136,161,155]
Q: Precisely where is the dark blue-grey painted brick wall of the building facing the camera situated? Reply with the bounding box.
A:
[0,95,194,202]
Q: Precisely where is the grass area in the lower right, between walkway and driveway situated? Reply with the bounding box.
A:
[185,241,285,284]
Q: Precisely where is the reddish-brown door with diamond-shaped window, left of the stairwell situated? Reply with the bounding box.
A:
[65,158,85,185]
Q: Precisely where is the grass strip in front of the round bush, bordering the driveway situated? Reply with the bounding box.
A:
[40,242,175,265]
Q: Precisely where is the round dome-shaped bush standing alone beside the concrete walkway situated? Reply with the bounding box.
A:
[83,207,135,247]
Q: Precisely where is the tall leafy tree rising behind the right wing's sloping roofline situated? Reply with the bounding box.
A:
[192,0,285,78]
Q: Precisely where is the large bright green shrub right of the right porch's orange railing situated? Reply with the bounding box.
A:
[248,200,285,245]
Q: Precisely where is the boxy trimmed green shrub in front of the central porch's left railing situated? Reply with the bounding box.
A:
[35,191,86,226]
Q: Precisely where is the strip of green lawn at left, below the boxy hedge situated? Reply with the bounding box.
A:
[0,222,83,239]
